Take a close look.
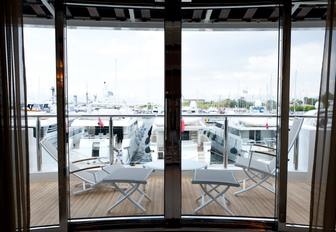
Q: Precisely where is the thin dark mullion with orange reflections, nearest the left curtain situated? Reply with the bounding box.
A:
[55,0,69,231]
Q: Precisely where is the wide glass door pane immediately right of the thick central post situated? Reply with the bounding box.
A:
[181,5,279,218]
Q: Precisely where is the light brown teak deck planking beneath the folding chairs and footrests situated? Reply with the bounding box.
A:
[30,175,310,226]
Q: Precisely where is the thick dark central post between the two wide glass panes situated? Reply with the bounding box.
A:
[164,0,182,223]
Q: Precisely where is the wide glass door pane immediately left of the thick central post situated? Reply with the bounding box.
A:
[67,4,164,219]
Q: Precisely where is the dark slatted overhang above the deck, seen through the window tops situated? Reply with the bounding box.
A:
[23,0,327,27]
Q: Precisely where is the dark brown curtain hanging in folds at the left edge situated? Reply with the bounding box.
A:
[0,0,29,232]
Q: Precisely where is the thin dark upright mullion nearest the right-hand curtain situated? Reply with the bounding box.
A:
[276,0,292,230]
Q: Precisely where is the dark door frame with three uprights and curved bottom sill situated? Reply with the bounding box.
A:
[55,0,292,231]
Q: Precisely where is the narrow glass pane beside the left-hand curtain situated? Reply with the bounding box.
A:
[24,23,59,226]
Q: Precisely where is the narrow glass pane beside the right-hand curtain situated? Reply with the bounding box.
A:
[287,2,326,225]
